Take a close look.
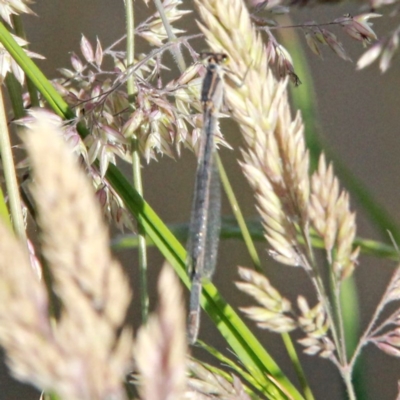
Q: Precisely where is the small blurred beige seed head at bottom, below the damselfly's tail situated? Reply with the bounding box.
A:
[135,266,187,400]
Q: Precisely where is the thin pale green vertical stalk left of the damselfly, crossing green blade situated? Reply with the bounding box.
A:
[125,0,149,323]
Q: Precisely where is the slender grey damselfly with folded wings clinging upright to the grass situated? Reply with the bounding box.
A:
[187,53,228,344]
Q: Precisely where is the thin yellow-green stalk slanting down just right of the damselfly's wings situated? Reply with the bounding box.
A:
[217,154,263,272]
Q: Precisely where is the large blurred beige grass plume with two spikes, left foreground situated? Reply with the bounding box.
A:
[0,111,132,400]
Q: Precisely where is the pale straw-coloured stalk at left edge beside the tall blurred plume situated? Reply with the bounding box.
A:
[0,85,27,244]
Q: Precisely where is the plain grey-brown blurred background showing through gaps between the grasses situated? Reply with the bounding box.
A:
[0,0,400,400]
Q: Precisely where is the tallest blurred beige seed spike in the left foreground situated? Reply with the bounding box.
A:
[23,110,130,326]
